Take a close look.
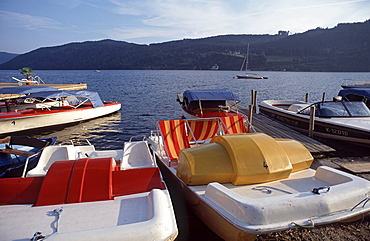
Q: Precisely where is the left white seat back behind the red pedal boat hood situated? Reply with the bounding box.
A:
[27,145,76,177]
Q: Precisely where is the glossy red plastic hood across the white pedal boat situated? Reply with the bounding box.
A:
[0,158,166,206]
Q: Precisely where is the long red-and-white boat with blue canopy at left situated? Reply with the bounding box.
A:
[0,86,121,135]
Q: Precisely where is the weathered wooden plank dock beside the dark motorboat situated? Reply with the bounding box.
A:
[239,108,335,156]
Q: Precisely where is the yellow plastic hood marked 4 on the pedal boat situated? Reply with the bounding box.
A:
[177,133,313,185]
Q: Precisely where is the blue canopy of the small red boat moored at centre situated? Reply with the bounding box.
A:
[183,89,239,102]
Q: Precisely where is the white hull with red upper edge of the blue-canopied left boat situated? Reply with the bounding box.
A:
[0,103,121,135]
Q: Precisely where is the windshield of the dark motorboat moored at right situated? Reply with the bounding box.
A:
[299,101,370,117]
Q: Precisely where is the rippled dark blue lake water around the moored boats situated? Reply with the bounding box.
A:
[0,70,370,240]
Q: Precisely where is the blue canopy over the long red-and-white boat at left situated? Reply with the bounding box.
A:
[25,90,104,107]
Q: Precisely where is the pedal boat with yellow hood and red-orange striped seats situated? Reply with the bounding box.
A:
[148,117,370,240]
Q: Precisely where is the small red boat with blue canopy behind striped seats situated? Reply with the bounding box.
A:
[177,89,247,118]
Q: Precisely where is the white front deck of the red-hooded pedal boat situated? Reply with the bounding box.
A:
[0,189,177,241]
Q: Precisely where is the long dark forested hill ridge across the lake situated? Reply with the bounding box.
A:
[0,20,370,71]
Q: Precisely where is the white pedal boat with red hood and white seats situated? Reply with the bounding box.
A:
[0,140,178,241]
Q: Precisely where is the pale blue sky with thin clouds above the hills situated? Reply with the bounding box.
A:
[0,0,370,54]
